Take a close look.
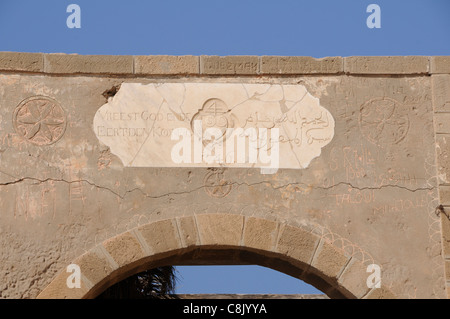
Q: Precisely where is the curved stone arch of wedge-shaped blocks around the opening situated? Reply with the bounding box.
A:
[38,214,395,299]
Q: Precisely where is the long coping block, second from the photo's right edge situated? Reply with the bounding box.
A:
[344,56,430,74]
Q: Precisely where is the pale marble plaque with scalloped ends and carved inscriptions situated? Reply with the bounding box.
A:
[93,83,335,172]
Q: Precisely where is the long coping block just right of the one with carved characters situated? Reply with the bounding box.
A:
[261,56,344,74]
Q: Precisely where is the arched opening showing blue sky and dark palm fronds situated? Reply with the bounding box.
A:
[96,265,328,299]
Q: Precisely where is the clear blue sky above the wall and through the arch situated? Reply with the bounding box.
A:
[0,0,450,293]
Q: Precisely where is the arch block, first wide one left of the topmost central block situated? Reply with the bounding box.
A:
[137,219,181,254]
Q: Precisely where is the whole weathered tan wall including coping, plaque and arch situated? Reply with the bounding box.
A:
[0,52,450,298]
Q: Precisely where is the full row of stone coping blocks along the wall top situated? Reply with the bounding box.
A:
[0,52,450,76]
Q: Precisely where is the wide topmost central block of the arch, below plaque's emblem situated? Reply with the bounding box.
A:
[196,214,244,246]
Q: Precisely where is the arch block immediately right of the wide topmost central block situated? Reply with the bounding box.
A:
[243,217,278,251]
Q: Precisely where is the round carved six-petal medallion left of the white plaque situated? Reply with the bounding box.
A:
[13,96,67,146]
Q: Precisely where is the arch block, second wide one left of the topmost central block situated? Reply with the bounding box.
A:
[103,232,145,267]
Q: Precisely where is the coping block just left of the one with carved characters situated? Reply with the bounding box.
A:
[134,55,200,75]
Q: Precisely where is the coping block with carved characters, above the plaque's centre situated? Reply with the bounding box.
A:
[200,56,259,75]
